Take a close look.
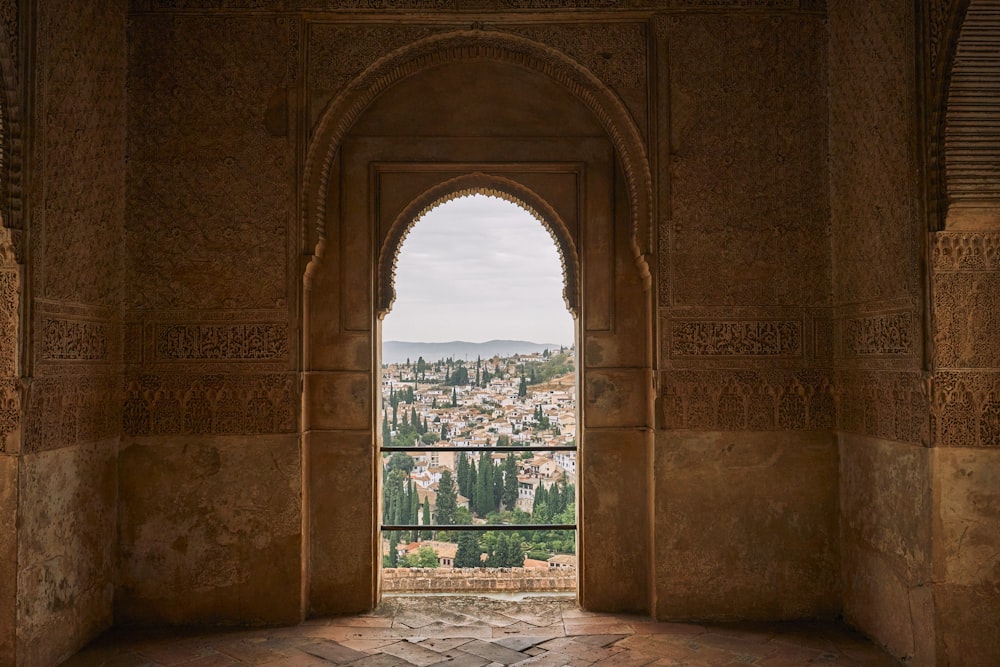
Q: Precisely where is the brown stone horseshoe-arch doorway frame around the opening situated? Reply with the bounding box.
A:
[301,31,655,614]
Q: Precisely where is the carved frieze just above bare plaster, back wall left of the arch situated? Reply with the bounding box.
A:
[121,373,298,436]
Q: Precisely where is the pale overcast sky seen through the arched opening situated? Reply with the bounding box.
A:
[382,195,573,345]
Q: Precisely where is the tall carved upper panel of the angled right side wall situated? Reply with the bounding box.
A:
[829,0,922,303]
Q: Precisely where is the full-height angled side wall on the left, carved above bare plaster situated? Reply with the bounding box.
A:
[14,0,127,665]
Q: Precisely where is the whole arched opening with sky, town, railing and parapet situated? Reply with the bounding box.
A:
[380,194,577,593]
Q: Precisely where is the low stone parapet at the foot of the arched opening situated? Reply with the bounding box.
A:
[381,567,576,594]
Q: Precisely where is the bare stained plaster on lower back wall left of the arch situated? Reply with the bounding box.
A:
[115,436,302,625]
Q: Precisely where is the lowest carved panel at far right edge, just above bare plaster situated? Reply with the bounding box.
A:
[931,370,1000,447]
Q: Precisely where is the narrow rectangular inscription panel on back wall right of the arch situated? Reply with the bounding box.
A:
[670,320,802,357]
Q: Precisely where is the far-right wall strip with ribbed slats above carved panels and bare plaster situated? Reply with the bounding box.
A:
[929,0,1000,665]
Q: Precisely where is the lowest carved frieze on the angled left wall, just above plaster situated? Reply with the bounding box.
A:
[24,377,121,452]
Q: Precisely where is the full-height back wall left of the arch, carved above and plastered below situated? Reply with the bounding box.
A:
[116,13,302,623]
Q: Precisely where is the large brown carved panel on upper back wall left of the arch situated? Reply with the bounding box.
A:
[127,14,299,310]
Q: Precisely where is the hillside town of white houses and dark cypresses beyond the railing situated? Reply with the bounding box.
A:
[381,348,576,569]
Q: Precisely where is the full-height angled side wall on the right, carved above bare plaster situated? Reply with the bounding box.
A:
[828,0,936,665]
